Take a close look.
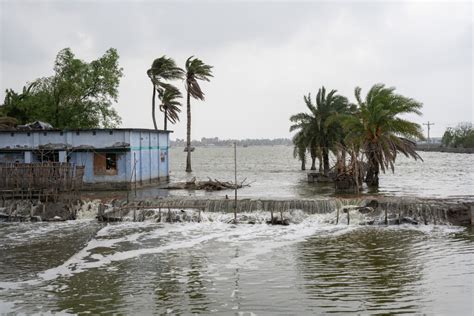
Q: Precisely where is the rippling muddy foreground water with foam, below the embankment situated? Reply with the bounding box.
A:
[0,211,474,315]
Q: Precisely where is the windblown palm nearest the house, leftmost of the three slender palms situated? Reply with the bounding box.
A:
[146,56,184,129]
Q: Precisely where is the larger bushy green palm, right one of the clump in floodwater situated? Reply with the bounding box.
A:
[343,84,423,187]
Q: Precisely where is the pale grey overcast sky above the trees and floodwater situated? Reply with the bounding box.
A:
[0,0,473,139]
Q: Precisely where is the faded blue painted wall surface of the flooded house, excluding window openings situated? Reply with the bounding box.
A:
[0,129,169,188]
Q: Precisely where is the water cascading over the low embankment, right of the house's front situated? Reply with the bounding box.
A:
[96,198,462,225]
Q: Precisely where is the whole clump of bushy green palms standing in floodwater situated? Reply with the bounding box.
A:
[290,84,423,192]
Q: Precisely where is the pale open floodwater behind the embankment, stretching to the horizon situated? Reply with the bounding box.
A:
[164,146,474,198]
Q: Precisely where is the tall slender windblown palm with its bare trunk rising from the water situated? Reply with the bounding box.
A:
[185,56,213,172]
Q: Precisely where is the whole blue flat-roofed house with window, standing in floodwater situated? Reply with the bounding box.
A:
[0,128,170,189]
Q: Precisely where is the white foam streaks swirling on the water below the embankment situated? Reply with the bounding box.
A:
[0,211,463,289]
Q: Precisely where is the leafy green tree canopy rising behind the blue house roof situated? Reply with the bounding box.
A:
[0,48,123,128]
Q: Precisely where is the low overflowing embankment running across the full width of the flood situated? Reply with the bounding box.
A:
[0,197,474,225]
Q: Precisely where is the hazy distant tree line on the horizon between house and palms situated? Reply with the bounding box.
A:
[171,137,293,147]
